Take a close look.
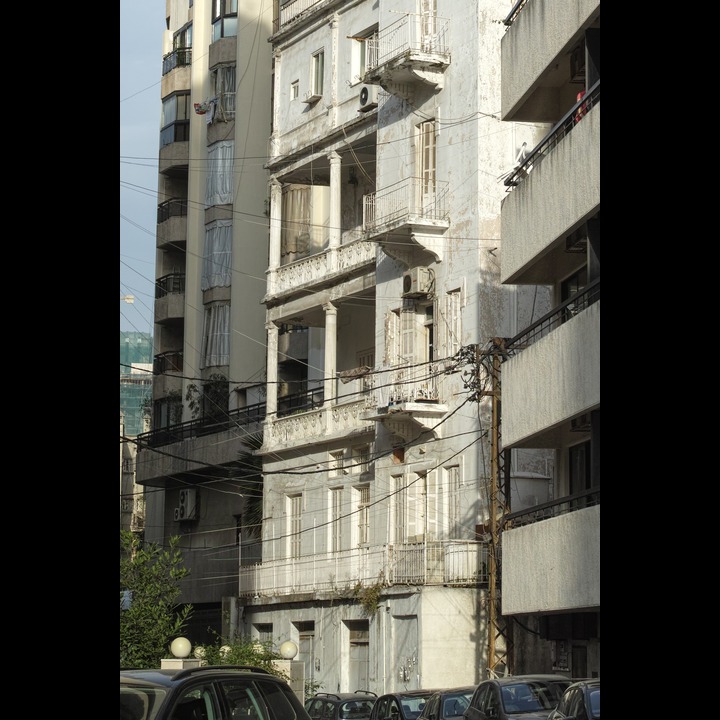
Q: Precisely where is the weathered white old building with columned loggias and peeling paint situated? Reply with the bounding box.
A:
[239,0,551,693]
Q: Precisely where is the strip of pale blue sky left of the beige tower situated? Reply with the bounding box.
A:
[120,0,165,333]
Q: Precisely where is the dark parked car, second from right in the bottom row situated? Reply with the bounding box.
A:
[463,675,571,720]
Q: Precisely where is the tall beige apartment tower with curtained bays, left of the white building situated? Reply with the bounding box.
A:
[138,0,272,642]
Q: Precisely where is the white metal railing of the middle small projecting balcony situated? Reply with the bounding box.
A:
[363,177,448,233]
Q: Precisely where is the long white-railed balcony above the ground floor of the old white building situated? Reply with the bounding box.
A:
[239,540,488,598]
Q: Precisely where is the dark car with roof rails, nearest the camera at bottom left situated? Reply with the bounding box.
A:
[120,665,310,720]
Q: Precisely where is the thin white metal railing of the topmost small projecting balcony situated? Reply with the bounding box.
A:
[367,13,450,71]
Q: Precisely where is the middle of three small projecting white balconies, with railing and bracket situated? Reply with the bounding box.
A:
[363,177,450,266]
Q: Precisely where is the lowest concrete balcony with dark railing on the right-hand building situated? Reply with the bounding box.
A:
[501,488,600,615]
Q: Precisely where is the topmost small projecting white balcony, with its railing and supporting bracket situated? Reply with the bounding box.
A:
[363,13,450,102]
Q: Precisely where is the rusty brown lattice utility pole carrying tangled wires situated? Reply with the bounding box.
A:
[477,337,514,677]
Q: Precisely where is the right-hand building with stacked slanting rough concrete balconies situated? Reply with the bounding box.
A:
[501,0,600,677]
